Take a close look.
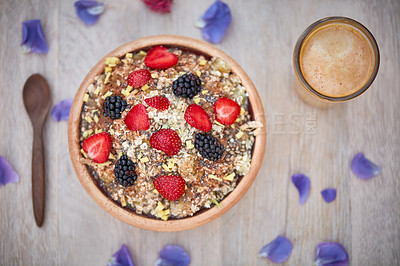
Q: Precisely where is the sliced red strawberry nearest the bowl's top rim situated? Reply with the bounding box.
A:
[144,46,179,69]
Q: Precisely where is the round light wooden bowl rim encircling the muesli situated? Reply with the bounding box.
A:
[68,35,266,231]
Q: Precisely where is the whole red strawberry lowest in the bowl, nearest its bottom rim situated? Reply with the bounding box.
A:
[153,175,185,200]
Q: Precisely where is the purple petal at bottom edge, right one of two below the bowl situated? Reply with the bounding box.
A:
[154,245,190,266]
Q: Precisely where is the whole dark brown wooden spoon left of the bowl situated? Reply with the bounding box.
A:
[22,74,50,227]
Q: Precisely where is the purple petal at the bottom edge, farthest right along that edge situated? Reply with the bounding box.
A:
[314,242,349,266]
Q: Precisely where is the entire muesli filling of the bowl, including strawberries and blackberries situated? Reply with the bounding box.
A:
[80,46,262,220]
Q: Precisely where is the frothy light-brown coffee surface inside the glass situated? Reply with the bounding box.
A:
[300,24,375,97]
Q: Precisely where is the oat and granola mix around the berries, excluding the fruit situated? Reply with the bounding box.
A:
[80,48,262,220]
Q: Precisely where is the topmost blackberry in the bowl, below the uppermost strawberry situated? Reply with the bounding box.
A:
[172,73,201,99]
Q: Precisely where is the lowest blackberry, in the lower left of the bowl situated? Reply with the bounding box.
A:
[114,155,137,187]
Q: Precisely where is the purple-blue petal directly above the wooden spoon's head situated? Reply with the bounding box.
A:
[21,19,49,54]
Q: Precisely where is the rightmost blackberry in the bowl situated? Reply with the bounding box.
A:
[194,133,225,162]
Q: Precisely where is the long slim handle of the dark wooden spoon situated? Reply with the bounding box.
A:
[32,128,45,227]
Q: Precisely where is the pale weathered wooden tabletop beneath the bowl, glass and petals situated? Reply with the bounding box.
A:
[0,0,400,265]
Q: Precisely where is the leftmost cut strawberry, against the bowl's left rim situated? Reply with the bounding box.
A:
[82,132,111,163]
